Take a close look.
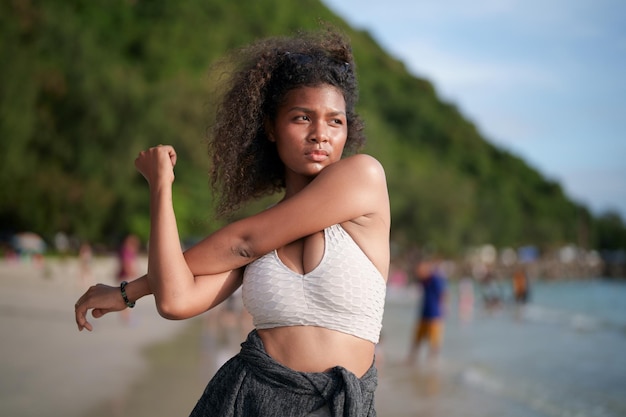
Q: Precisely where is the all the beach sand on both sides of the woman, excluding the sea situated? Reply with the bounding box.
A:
[0,258,528,417]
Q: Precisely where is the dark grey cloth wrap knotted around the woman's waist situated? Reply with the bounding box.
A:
[190,330,378,417]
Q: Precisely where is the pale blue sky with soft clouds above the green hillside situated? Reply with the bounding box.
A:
[323,0,626,221]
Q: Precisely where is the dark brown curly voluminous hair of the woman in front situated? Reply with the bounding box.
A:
[209,30,365,216]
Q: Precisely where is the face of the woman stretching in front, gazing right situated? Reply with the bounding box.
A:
[267,84,348,181]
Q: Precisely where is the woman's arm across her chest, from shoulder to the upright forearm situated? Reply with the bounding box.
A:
[180,154,391,275]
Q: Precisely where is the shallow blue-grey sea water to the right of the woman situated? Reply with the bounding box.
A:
[381,279,626,417]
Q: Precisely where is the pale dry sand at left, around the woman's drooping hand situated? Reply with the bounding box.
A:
[0,258,187,417]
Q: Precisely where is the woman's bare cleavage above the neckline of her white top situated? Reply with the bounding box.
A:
[276,232,325,275]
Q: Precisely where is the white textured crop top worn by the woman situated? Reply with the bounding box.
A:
[242,224,386,343]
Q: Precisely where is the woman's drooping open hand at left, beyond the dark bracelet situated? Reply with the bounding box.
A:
[74,284,127,331]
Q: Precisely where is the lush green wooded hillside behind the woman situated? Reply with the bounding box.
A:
[0,0,625,253]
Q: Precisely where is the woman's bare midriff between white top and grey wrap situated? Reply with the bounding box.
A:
[258,326,374,378]
